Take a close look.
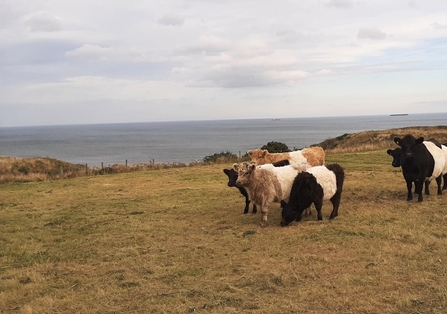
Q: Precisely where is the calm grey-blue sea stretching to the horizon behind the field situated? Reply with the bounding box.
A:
[0,112,447,167]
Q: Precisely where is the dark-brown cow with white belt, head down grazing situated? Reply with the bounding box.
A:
[281,164,345,227]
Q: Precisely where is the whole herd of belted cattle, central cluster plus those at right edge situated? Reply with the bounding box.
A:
[223,135,447,226]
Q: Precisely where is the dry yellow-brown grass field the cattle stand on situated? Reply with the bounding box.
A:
[0,149,447,313]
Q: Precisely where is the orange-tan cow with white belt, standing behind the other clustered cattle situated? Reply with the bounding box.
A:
[247,146,326,166]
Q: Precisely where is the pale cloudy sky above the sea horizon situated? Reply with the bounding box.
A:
[0,0,447,127]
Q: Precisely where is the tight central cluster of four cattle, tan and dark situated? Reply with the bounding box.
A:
[224,146,345,226]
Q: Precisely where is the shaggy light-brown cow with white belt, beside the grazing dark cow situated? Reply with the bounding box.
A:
[233,162,308,227]
